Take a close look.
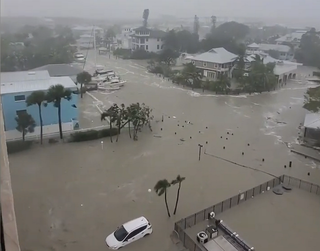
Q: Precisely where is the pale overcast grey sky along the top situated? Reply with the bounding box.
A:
[1,0,320,19]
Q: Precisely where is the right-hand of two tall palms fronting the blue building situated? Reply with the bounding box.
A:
[46,84,72,139]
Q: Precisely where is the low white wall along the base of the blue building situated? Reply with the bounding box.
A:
[6,122,73,141]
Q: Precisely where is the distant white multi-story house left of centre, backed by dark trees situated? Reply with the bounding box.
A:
[131,27,167,52]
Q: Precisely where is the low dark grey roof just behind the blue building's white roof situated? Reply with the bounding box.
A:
[31,64,83,83]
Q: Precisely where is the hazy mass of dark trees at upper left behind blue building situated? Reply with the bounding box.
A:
[1,26,76,72]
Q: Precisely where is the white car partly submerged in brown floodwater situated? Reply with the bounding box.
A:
[106,216,152,250]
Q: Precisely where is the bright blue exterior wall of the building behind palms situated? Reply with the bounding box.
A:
[1,92,79,131]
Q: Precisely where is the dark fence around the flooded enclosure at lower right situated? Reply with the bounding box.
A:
[174,175,320,251]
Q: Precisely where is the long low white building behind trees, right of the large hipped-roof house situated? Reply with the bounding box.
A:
[246,43,294,60]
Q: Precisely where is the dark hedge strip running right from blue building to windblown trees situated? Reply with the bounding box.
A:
[70,128,118,142]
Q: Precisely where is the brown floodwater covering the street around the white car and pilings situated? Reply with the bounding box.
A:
[9,50,320,251]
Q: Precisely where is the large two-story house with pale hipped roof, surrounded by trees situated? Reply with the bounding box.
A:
[191,47,238,81]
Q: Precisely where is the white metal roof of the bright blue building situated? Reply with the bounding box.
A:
[0,71,77,94]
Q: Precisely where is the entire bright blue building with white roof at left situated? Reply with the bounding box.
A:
[1,71,79,140]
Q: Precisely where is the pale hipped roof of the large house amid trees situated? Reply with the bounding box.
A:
[193,47,238,64]
